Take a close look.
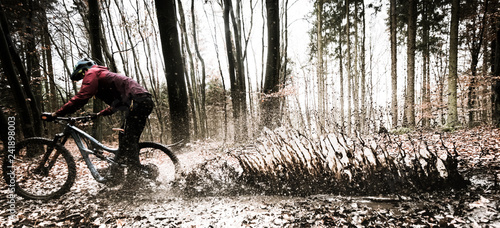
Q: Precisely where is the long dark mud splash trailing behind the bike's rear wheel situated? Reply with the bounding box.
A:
[174,129,469,196]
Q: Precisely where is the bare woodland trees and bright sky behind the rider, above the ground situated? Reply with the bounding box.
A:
[0,0,500,146]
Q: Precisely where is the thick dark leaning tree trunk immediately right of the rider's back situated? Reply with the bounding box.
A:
[155,0,190,143]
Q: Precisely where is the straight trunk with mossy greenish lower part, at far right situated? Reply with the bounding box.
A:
[447,0,460,127]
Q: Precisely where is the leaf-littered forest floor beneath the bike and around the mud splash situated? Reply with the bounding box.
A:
[0,127,500,227]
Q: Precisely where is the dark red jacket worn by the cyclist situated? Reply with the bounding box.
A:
[56,65,149,116]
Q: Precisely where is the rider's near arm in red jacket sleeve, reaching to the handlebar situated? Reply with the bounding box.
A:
[54,69,98,116]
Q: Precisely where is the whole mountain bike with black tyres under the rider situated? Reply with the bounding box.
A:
[2,113,179,200]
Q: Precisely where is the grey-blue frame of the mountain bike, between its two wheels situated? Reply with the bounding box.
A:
[47,121,119,183]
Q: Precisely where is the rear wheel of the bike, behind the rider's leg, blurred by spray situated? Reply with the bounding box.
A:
[139,142,179,183]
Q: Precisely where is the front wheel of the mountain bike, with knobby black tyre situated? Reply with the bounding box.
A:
[2,137,76,200]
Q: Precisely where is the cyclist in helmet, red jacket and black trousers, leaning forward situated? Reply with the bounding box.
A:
[52,58,154,183]
